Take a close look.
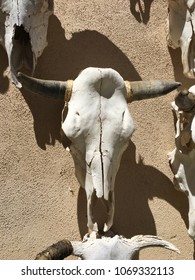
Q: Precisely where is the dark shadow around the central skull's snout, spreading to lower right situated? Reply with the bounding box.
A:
[77,141,188,241]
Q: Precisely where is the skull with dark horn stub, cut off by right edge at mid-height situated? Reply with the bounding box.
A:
[168,86,195,240]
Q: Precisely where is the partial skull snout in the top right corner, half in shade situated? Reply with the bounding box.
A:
[167,0,195,79]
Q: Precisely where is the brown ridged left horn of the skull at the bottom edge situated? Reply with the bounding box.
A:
[35,239,73,260]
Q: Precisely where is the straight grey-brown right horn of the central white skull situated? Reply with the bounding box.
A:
[125,80,181,102]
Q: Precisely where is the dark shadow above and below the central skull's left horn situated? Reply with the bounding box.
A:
[19,16,141,149]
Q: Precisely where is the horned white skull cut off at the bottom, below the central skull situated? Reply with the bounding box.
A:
[36,235,180,260]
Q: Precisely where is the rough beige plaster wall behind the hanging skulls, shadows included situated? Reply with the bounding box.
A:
[0,0,194,260]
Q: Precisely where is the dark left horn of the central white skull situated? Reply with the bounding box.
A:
[18,72,73,101]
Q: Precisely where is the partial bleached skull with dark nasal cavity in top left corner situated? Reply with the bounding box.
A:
[0,0,53,87]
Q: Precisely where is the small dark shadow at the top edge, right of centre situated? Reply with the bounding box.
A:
[130,0,153,24]
